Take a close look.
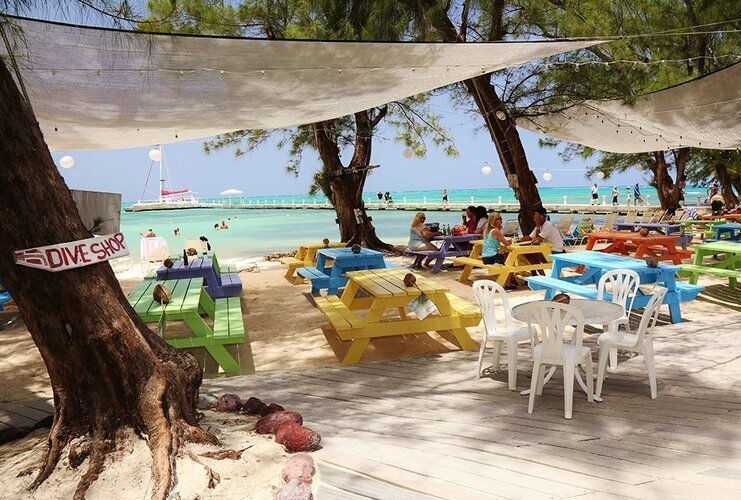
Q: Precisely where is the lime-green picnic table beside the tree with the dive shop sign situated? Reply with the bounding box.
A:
[127,278,245,374]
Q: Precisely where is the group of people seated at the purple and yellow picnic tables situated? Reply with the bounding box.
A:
[409,206,565,288]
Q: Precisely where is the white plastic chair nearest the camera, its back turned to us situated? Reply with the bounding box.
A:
[524,301,594,419]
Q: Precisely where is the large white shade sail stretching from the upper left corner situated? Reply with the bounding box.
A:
[0,18,600,151]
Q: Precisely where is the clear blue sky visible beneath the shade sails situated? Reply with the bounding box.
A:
[52,98,643,201]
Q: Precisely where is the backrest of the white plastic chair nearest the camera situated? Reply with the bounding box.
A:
[524,300,584,362]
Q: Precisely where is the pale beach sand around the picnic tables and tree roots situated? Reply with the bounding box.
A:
[0,258,738,500]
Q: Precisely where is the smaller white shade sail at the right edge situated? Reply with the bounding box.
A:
[517,63,741,153]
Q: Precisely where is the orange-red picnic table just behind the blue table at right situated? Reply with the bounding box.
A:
[587,231,692,265]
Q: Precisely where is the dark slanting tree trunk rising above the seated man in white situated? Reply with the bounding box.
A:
[419,0,543,234]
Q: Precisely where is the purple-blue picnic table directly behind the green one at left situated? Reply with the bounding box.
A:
[157,253,242,299]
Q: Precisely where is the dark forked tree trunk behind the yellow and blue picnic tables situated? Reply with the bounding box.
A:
[312,113,393,250]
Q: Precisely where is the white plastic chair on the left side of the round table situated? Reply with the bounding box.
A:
[473,280,530,391]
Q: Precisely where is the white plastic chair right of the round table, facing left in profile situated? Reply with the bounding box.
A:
[597,286,666,399]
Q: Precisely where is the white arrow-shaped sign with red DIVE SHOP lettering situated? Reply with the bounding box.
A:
[15,233,129,272]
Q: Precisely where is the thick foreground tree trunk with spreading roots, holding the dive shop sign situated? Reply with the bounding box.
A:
[0,55,216,499]
